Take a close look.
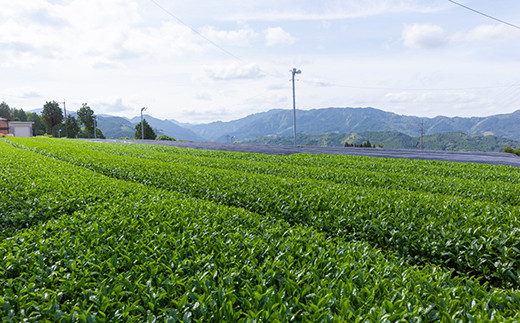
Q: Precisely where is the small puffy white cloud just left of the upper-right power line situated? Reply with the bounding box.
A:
[402,24,448,49]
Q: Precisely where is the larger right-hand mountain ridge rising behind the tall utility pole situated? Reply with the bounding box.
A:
[189,108,520,142]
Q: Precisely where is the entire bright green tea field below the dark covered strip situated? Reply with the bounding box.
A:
[0,138,520,322]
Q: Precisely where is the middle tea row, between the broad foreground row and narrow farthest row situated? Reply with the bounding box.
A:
[10,139,520,288]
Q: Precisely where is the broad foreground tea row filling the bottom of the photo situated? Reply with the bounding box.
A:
[4,140,520,322]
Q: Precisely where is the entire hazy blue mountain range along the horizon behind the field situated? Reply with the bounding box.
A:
[90,108,520,146]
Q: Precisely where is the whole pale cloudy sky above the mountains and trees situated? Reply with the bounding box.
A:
[0,0,520,123]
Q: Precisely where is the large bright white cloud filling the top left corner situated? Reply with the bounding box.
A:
[0,0,208,68]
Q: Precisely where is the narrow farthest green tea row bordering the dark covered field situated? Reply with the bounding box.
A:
[69,141,520,206]
